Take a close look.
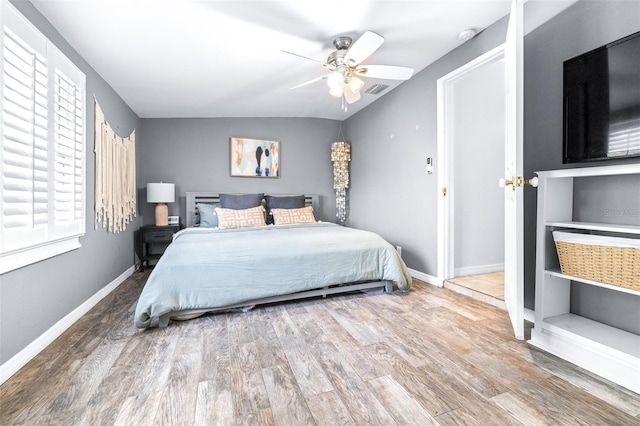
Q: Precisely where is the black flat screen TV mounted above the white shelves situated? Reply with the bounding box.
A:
[563,32,640,163]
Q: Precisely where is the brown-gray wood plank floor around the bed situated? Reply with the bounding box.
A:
[0,273,640,426]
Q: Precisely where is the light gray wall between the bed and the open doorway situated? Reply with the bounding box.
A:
[346,19,506,276]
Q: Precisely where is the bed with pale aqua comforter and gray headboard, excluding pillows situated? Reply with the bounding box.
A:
[134,193,411,328]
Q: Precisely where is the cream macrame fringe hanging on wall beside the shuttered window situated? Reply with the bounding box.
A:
[95,101,136,233]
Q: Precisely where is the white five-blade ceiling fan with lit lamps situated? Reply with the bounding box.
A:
[283,31,413,111]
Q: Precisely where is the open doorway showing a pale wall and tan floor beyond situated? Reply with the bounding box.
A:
[438,46,506,308]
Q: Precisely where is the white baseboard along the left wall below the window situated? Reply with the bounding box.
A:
[0,266,136,385]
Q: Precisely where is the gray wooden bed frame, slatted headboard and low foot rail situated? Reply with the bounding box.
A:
[158,192,393,327]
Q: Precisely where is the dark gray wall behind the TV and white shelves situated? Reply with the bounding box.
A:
[524,0,640,326]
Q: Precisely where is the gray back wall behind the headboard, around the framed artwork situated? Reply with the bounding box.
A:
[137,118,340,223]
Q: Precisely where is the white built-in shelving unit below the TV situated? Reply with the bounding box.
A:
[529,164,640,393]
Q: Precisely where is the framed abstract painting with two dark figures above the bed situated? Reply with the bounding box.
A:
[230,137,280,178]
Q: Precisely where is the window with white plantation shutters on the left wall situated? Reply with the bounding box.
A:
[0,2,85,274]
